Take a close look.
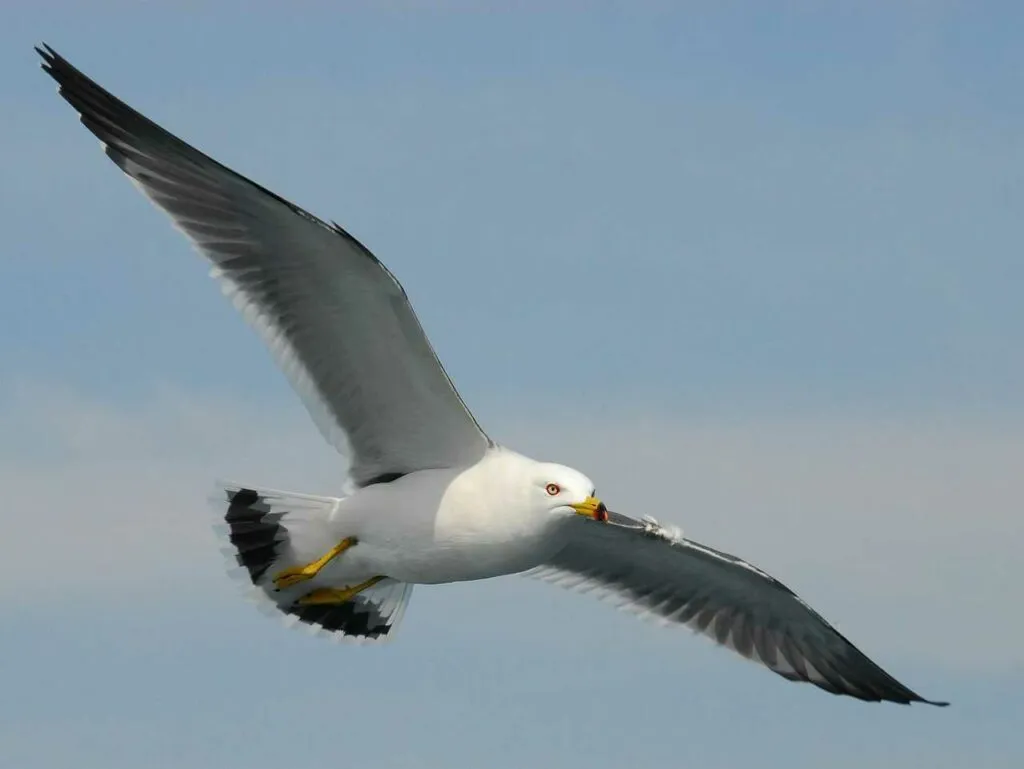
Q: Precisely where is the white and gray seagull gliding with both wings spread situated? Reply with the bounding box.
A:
[36,40,947,706]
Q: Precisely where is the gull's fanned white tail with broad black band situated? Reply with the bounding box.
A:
[215,484,413,642]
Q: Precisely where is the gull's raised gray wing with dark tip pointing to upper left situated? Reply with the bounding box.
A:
[37,47,490,485]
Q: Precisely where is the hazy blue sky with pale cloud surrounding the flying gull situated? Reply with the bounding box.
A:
[0,0,1024,769]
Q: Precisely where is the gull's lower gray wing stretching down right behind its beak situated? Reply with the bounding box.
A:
[529,513,946,706]
